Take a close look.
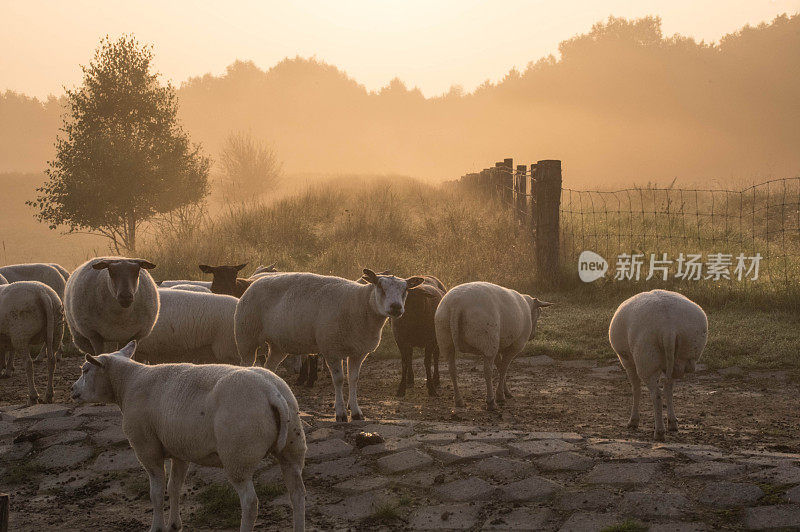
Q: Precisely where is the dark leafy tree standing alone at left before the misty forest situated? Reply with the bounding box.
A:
[28,36,210,253]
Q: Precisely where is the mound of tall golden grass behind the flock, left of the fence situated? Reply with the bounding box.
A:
[142,178,534,289]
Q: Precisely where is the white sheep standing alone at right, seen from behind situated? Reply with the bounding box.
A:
[608,290,708,441]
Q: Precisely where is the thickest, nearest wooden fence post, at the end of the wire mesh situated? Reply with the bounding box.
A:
[534,160,561,279]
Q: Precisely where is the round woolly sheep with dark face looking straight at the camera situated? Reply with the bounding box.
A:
[64,257,159,355]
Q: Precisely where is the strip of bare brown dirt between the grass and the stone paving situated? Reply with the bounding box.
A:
[0,350,800,453]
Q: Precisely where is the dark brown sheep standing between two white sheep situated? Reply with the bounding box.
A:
[392,275,447,397]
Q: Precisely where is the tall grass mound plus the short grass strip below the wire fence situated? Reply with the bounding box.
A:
[140,178,800,372]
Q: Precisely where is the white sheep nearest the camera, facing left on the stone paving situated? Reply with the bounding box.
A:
[71,341,306,531]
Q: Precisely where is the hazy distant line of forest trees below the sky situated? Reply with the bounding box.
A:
[0,15,800,186]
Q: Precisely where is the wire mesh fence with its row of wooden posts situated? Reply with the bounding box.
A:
[457,159,800,289]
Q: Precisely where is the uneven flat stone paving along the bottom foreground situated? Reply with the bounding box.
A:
[0,405,800,531]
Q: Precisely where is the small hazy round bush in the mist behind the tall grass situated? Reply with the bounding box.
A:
[220,132,281,199]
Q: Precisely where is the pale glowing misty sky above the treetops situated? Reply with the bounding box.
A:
[0,0,800,98]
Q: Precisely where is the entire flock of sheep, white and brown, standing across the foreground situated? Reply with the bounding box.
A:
[0,257,708,530]
